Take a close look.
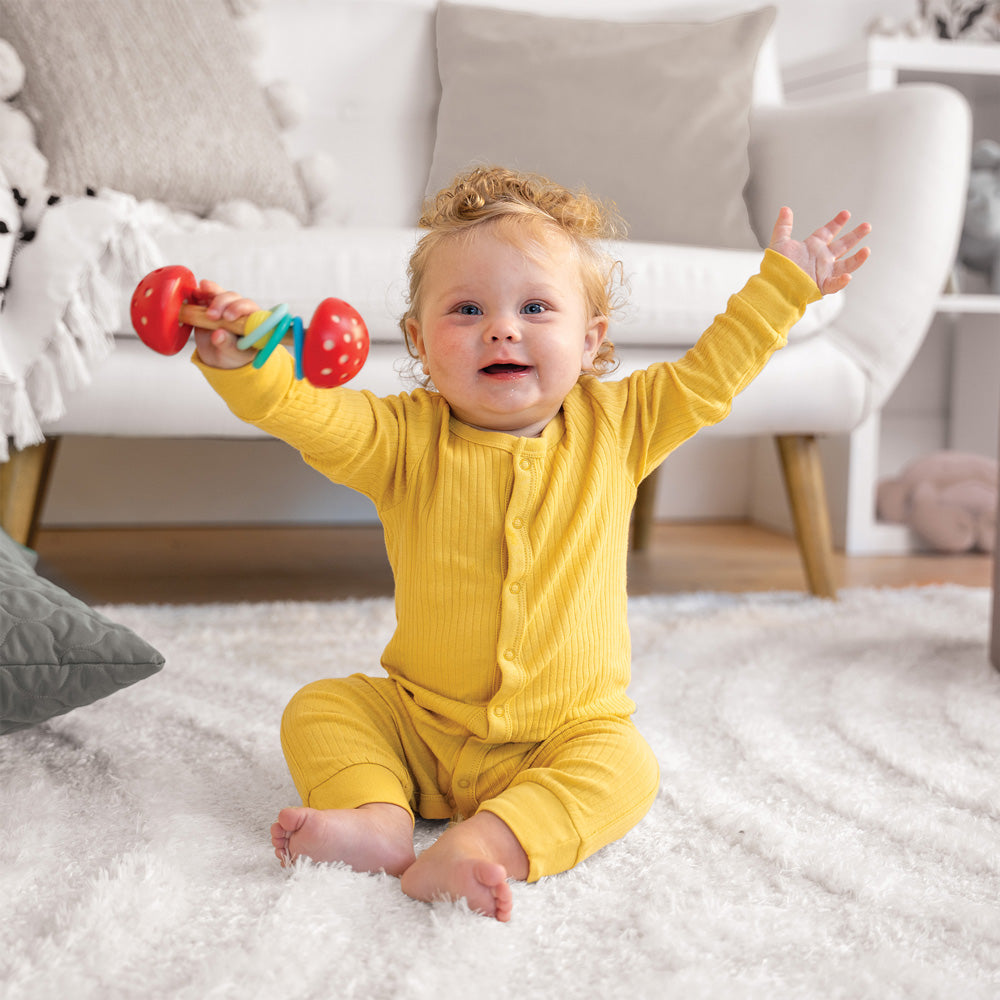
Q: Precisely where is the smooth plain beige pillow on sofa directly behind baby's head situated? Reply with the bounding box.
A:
[427,3,775,249]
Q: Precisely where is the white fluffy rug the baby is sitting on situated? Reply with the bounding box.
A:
[0,587,1000,1000]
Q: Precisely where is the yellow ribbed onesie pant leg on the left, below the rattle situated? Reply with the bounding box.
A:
[281,674,451,816]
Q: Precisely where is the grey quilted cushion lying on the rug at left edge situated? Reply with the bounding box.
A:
[0,532,163,734]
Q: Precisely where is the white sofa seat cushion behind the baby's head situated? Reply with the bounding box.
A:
[131,222,846,356]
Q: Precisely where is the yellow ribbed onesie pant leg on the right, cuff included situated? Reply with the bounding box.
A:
[479,718,660,882]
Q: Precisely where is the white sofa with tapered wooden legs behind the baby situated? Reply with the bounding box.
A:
[0,0,970,595]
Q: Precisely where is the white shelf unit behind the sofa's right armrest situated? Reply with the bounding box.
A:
[784,36,1000,555]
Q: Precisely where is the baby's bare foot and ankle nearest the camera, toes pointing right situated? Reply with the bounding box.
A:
[400,812,528,921]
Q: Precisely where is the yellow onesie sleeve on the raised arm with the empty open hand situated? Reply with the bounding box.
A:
[600,250,822,482]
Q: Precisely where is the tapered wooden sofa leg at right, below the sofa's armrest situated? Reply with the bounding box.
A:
[775,434,837,598]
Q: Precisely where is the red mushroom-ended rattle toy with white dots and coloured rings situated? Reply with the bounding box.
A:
[130,265,368,389]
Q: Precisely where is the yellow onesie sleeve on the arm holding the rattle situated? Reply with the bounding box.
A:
[192,349,435,506]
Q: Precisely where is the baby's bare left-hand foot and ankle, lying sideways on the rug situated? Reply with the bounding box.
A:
[271,802,416,875]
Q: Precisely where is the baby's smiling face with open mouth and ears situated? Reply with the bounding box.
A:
[408,226,608,436]
